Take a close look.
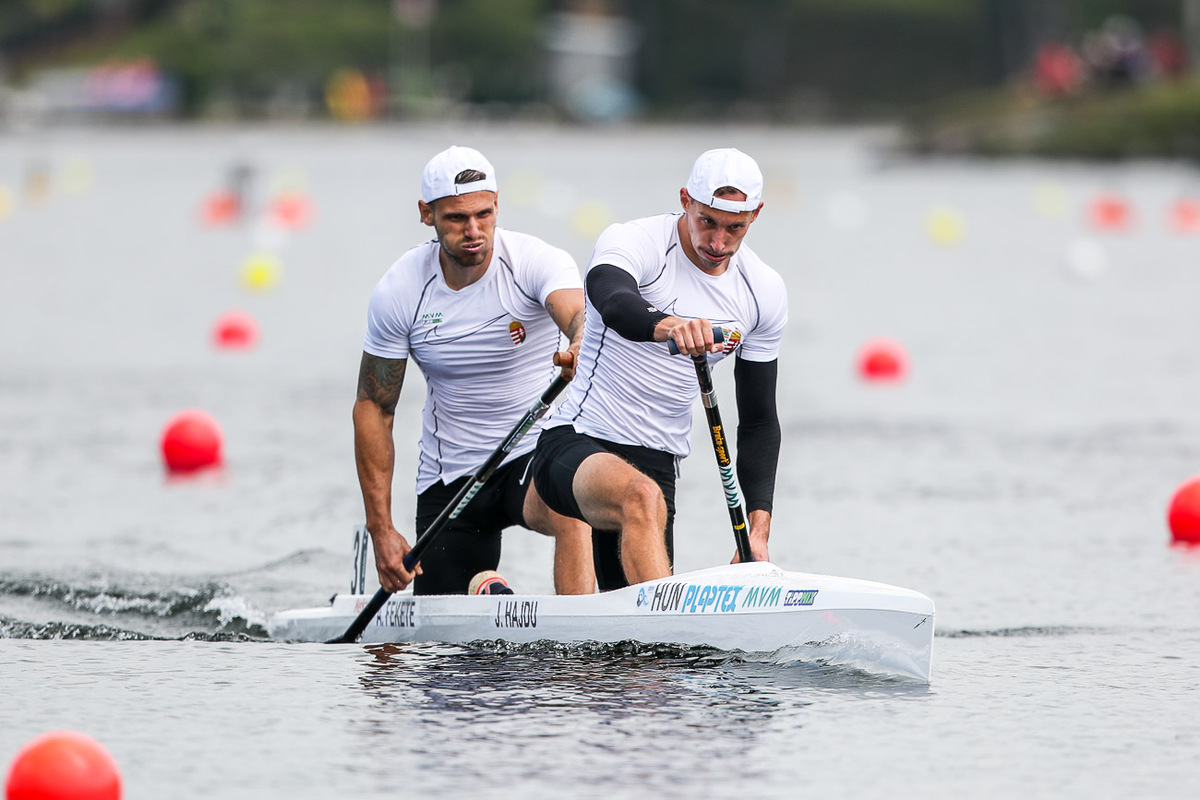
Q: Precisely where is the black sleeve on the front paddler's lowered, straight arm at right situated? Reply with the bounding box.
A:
[733,359,780,513]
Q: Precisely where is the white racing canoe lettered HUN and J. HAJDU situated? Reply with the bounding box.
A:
[270,561,934,682]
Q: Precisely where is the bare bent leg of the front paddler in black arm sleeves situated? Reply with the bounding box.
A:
[571,453,671,583]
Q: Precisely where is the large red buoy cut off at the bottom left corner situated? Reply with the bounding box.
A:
[5,730,121,800]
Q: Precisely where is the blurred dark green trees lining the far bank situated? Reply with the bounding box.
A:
[0,0,1182,121]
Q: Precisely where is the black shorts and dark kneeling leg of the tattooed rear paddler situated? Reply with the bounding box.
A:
[413,453,533,595]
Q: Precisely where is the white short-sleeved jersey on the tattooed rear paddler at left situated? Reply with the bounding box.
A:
[362,228,583,492]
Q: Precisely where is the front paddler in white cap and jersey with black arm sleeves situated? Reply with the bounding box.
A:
[533,149,787,590]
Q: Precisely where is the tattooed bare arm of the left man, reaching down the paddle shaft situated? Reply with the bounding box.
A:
[354,353,413,593]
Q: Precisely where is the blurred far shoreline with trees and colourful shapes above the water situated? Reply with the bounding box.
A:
[0,0,1200,160]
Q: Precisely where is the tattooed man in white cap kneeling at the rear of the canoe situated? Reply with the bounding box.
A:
[354,146,595,595]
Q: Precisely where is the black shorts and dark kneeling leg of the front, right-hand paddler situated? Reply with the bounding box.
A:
[530,425,676,591]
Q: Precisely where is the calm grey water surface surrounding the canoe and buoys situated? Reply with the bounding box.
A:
[0,127,1200,800]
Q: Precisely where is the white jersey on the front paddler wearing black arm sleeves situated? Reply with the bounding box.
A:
[548,213,787,457]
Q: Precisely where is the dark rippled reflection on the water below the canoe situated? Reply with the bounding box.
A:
[356,643,928,789]
